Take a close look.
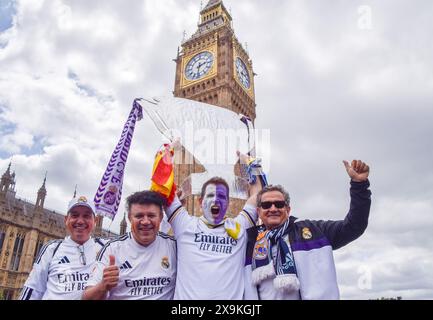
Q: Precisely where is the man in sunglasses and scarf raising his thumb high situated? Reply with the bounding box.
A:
[245,160,371,300]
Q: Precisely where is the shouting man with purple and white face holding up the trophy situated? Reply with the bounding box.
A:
[161,155,262,300]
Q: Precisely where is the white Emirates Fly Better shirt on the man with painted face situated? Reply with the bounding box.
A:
[166,197,257,300]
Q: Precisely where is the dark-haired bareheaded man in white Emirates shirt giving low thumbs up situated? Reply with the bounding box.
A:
[83,191,176,300]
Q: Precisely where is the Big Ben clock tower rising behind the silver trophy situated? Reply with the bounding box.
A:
[173,0,256,215]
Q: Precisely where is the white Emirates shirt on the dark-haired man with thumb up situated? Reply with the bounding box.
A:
[87,232,176,300]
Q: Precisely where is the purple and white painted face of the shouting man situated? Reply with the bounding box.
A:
[202,184,229,224]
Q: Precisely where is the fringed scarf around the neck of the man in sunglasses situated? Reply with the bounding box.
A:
[252,220,300,292]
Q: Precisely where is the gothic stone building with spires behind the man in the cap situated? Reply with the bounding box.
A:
[0,164,122,300]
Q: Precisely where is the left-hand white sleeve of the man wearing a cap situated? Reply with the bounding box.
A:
[20,240,59,300]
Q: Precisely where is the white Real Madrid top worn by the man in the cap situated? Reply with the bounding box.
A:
[20,236,106,300]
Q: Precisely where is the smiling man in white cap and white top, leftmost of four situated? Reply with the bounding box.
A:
[20,196,104,300]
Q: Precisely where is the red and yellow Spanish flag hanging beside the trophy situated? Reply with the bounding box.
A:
[150,144,176,206]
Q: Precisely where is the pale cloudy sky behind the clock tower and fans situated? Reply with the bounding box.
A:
[0,0,433,299]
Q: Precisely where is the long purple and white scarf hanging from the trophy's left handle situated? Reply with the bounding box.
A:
[94,99,143,220]
